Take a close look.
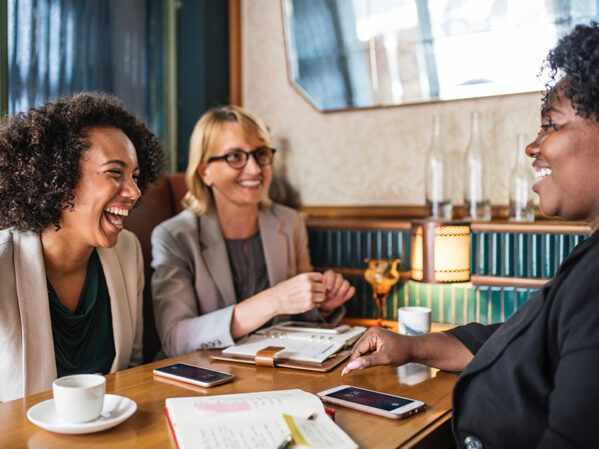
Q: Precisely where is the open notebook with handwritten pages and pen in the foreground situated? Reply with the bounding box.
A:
[165,389,358,449]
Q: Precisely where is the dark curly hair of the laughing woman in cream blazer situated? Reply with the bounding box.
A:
[0,92,165,234]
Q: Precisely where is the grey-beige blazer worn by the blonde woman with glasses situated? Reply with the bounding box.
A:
[152,204,338,357]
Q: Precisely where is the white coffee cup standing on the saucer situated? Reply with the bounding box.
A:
[52,374,106,423]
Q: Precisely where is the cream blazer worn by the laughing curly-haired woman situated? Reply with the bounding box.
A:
[0,229,144,401]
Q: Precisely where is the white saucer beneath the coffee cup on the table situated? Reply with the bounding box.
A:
[27,394,137,434]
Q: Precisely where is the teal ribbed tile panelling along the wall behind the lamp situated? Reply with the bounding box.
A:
[308,229,588,324]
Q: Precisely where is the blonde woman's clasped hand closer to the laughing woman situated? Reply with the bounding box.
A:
[270,273,326,315]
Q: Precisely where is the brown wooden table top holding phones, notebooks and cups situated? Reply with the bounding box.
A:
[0,351,457,449]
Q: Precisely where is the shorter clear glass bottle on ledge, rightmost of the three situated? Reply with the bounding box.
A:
[509,134,535,221]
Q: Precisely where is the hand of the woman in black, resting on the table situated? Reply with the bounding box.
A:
[341,327,413,376]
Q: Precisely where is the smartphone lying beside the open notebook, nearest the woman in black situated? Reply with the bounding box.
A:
[316,385,426,419]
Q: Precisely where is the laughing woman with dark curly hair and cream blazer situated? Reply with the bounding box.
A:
[0,92,164,401]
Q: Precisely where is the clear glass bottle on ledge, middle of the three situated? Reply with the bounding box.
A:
[464,112,491,221]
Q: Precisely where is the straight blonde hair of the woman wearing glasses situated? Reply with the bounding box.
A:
[181,105,272,215]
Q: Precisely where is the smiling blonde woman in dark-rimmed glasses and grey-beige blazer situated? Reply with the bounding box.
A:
[152,106,355,356]
